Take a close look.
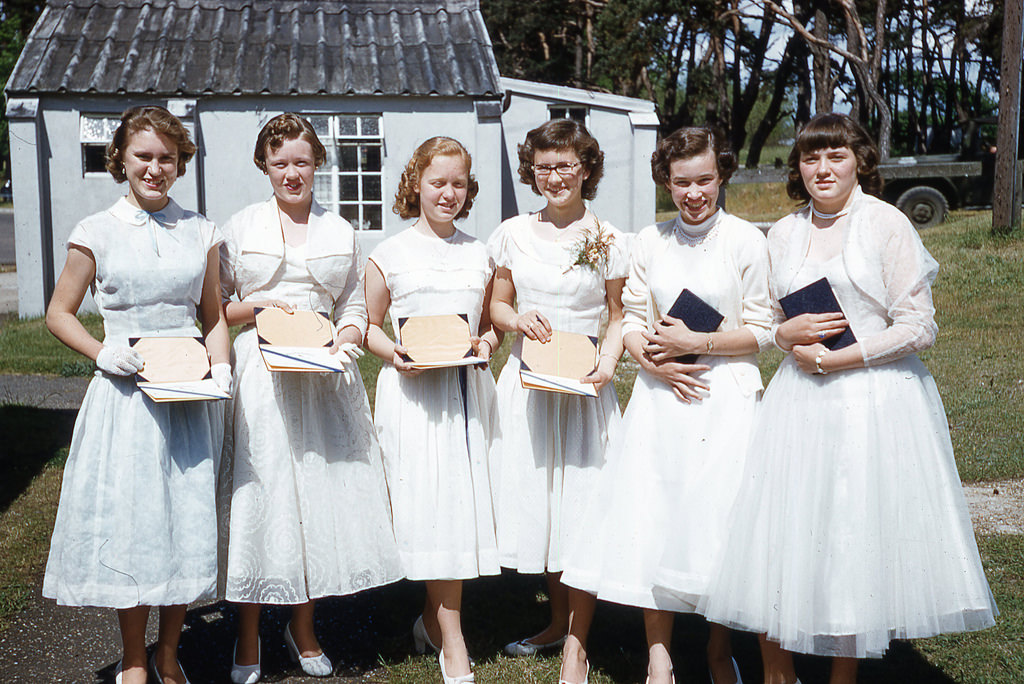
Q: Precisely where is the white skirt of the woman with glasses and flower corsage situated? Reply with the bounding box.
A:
[495,355,620,572]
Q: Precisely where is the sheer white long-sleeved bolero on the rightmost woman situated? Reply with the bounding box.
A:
[768,187,939,366]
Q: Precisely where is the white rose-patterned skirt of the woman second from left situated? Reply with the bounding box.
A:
[218,329,402,604]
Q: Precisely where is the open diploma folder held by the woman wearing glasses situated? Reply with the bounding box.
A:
[519,330,597,396]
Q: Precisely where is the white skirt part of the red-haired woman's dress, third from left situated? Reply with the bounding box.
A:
[374,366,501,580]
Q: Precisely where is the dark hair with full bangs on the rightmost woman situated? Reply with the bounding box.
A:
[785,114,884,202]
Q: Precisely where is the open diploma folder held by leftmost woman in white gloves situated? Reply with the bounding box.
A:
[128,337,230,402]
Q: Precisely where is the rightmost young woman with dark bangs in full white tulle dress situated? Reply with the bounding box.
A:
[702,114,997,684]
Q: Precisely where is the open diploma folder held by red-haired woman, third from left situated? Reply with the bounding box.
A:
[398,313,484,369]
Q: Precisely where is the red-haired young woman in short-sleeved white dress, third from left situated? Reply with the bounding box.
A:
[366,137,501,684]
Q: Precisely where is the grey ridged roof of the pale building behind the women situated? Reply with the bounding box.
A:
[6,0,501,97]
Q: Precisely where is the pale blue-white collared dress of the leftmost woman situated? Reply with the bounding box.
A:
[43,199,223,608]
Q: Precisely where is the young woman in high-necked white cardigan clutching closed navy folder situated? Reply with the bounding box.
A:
[564,128,771,684]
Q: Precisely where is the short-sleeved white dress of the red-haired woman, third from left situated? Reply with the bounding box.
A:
[370,227,500,580]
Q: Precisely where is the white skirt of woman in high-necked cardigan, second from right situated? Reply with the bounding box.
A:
[562,357,758,612]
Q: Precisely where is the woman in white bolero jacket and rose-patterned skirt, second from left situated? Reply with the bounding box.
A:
[219,114,402,684]
